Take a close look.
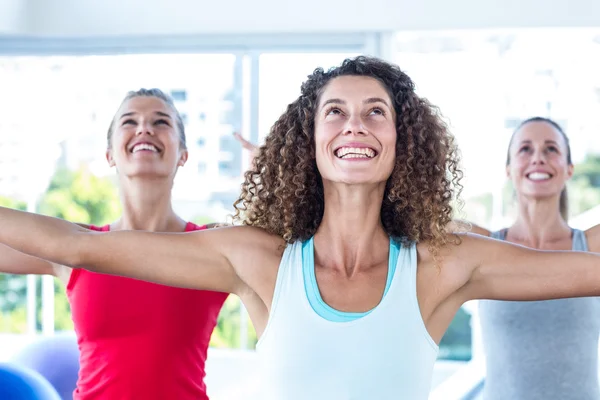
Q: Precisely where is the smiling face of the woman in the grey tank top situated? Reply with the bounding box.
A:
[506,121,573,198]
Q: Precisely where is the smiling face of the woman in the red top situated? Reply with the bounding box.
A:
[106,96,187,177]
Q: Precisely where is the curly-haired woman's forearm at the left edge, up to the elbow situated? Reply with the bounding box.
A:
[0,207,88,267]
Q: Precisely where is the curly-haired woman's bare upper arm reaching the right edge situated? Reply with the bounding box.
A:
[456,235,600,301]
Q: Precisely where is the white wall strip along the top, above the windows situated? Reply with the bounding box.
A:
[7,0,600,37]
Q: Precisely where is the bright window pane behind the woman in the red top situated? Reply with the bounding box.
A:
[0,54,241,332]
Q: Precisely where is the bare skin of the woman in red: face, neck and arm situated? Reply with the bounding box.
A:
[0,97,217,284]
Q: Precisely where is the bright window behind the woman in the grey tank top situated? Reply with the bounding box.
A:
[392,29,600,359]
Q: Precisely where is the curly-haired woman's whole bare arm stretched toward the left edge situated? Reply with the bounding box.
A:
[0,207,274,293]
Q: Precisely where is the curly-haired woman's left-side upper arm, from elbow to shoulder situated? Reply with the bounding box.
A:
[76,227,274,293]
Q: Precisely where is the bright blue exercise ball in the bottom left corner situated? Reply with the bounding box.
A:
[0,363,61,400]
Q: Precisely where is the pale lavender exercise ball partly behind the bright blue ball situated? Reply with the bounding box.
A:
[10,333,79,400]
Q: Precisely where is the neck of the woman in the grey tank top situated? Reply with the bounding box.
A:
[510,196,571,248]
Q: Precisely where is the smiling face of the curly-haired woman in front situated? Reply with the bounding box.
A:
[315,76,397,184]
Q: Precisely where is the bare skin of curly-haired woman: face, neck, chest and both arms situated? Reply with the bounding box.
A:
[0,76,600,342]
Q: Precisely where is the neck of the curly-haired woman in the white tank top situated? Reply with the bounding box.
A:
[315,183,389,275]
